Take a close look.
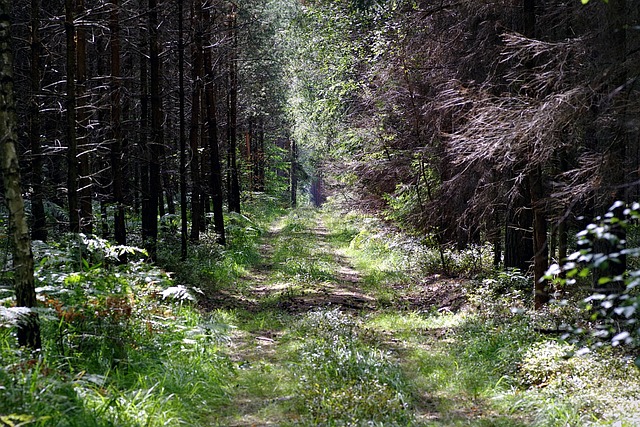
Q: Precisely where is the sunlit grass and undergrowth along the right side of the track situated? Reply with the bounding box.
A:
[326,201,640,427]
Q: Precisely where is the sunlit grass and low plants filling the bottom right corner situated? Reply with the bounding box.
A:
[365,312,640,426]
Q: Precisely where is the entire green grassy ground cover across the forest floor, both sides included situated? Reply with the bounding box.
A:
[0,199,640,427]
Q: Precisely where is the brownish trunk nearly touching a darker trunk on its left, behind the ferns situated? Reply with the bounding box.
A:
[75,0,93,234]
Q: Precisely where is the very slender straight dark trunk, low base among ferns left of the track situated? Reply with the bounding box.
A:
[178,0,188,261]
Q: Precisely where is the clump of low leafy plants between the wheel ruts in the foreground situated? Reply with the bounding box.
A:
[295,309,412,426]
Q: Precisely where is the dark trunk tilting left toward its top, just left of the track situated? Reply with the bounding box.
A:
[204,0,226,245]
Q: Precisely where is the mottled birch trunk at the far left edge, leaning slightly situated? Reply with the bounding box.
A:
[0,0,41,349]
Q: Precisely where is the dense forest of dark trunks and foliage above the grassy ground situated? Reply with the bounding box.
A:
[0,0,640,424]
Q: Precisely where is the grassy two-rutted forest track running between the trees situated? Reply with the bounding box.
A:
[210,210,521,427]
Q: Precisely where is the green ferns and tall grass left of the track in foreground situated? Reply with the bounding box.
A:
[0,235,233,426]
